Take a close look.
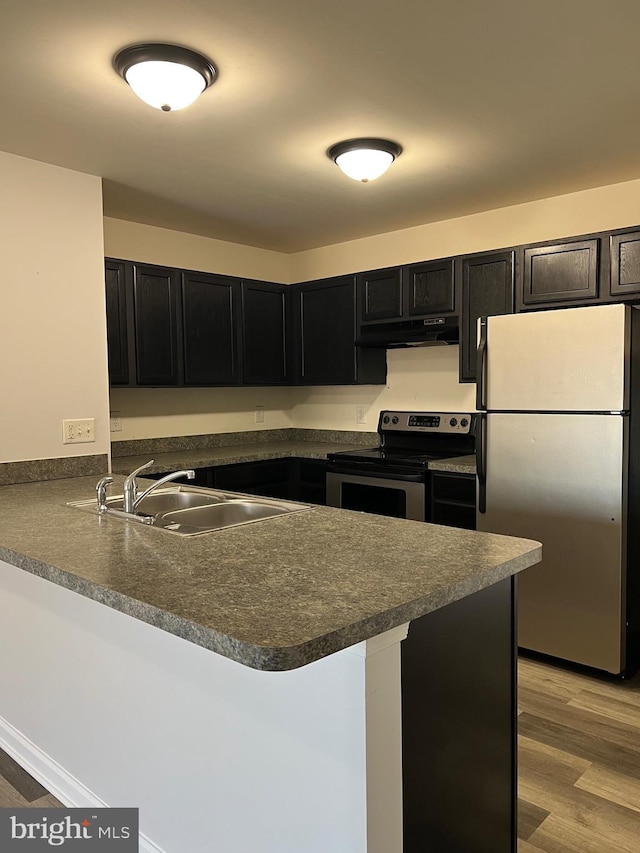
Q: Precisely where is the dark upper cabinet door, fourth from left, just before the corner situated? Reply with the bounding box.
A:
[242,281,288,385]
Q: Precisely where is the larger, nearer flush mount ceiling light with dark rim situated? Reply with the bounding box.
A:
[113,44,218,112]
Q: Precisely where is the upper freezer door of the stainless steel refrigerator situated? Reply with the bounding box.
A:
[481,305,633,412]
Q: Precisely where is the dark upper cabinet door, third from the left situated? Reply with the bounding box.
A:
[182,272,240,385]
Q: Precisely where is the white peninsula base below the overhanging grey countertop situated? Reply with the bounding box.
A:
[0,561,407,853]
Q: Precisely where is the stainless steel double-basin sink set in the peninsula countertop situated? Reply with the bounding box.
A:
[67,485,312,536]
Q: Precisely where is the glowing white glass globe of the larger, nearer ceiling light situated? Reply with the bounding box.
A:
[125,61,206,112]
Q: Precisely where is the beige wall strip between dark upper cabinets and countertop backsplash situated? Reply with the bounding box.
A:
[111,346,475,441]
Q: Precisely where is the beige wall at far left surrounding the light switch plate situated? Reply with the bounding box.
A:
[0,152,109,462]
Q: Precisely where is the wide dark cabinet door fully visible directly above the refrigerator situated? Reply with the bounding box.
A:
[522,239,599,307]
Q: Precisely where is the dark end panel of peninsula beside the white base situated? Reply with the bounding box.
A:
[401,578,517,853]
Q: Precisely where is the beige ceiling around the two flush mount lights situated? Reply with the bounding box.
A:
[0,0,640,252]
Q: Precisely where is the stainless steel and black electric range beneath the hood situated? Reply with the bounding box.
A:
[327,410,476,521]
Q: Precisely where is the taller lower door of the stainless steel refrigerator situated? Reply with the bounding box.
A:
[478,413,628,673]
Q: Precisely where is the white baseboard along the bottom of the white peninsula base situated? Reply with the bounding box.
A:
[0,717,165,853]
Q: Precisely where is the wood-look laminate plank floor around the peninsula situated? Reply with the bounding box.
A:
[0,658,640,853]
